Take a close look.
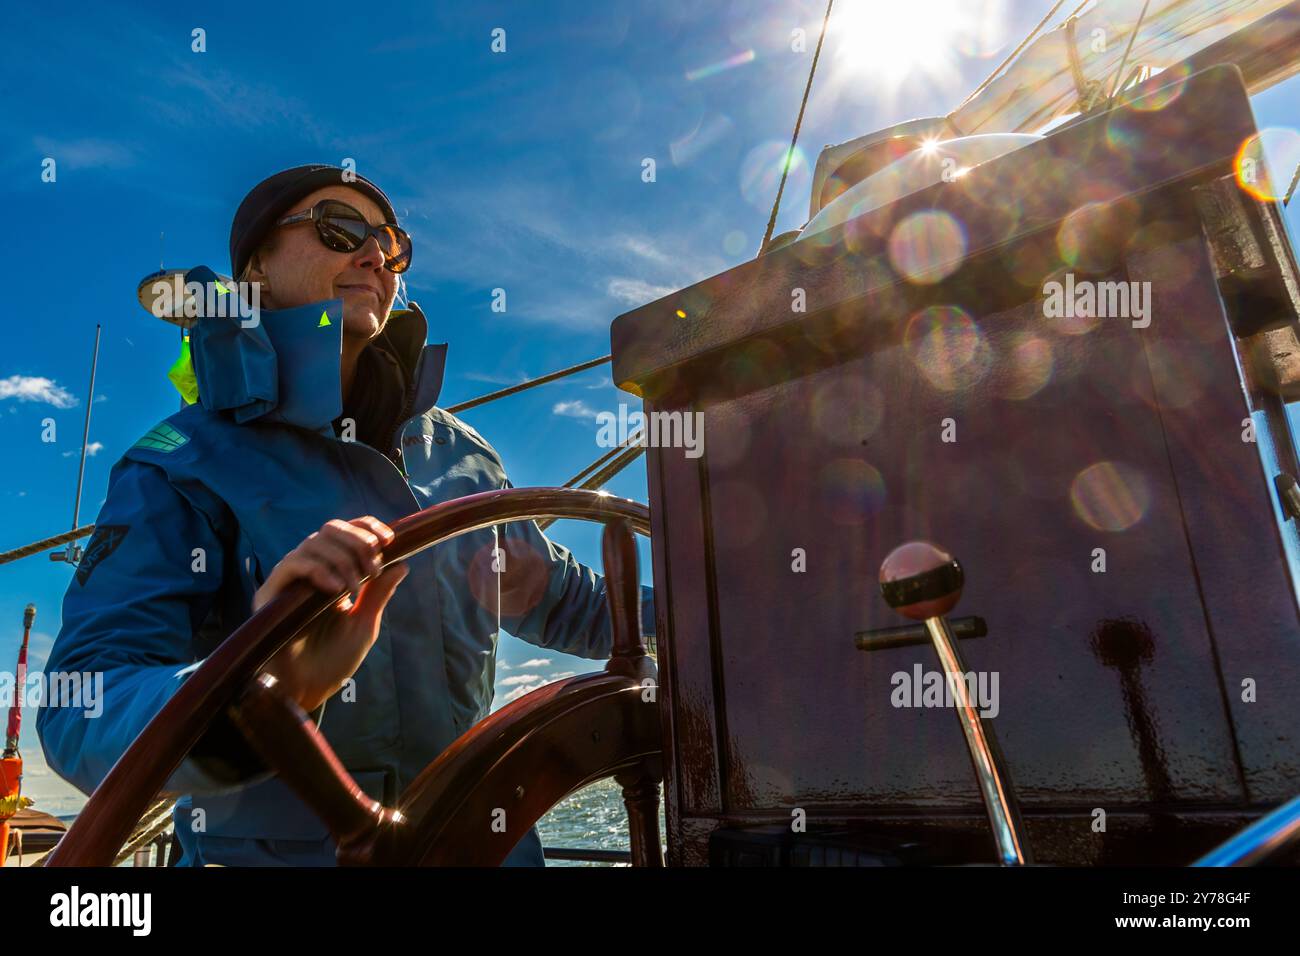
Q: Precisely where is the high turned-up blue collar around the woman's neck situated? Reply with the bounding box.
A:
[182,267,447,433]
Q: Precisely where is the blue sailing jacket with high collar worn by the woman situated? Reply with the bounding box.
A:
[36,286,654,865]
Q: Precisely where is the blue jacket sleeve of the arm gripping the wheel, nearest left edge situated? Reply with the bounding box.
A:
[36,459,284,793]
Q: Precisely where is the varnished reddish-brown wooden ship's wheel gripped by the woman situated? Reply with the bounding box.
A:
[47,488,663,866]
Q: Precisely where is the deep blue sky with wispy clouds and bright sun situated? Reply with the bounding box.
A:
[0,0,1300,816]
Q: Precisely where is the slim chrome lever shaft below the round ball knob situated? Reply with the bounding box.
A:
[926,618,1030,866]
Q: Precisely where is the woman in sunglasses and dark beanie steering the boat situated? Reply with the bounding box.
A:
[36,165,654,866]
